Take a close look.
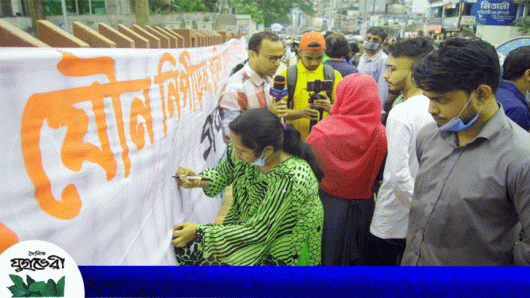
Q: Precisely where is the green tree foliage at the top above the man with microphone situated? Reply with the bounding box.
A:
[230,0,315,27]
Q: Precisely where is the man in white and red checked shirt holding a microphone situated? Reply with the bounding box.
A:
[219,32,287,143]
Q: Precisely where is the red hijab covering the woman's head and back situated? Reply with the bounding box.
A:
[306,73,386,199]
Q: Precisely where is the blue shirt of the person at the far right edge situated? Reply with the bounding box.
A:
[495,80,530,130]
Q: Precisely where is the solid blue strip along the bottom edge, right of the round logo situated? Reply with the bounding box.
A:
[79,266,530,298]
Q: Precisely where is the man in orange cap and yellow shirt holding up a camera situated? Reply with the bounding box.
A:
[281,32,342,141]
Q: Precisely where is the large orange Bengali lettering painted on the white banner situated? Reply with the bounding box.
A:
[21,43,242,220]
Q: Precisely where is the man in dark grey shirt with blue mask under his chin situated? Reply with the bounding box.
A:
[402,38,530,266]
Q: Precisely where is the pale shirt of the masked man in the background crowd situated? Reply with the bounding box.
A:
[357,50,388,111]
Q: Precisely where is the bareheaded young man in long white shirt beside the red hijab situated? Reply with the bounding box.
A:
[369,37,434,266]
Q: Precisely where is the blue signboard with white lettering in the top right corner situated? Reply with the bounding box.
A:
[471,0,517,26]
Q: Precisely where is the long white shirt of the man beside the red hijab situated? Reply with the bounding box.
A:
[370,95,434,239]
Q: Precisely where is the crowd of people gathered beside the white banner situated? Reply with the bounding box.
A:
[167,27,530,266]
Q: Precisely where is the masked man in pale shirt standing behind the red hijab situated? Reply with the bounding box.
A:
[357,27,388,114]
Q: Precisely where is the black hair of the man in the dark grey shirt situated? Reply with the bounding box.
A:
[412,38,501,94]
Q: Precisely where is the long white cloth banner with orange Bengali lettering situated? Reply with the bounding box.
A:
[0,38,247,265]
